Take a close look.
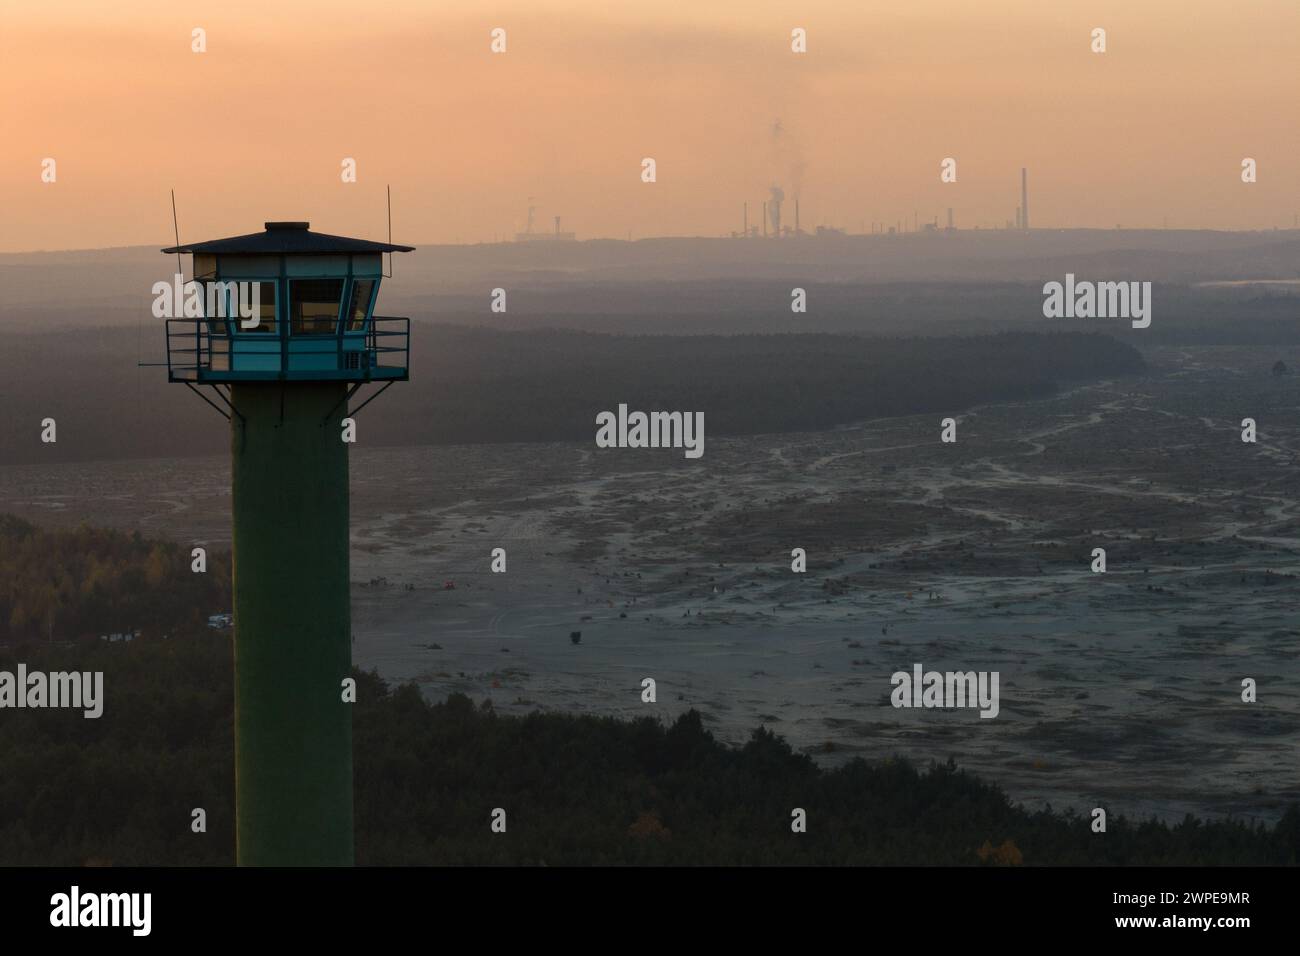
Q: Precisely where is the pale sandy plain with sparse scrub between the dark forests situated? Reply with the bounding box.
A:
[0,347,1300,819]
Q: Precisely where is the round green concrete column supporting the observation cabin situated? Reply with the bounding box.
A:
[230,382,352,866]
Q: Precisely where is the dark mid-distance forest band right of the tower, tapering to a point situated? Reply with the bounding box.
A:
[397,326,1144,442]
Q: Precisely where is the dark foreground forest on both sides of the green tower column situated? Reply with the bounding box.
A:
[0,635,1300,866]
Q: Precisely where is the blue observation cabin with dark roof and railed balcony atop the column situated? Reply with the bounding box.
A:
[163,222,412,385]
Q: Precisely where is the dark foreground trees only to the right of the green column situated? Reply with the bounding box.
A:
[356,676,1300,865]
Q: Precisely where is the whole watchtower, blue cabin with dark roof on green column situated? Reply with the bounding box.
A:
[163,222,412,866]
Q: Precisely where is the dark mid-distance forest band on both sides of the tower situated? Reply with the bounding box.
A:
[0,323,1144,463]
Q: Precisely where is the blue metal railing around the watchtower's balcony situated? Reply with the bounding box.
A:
[166,316,411,381]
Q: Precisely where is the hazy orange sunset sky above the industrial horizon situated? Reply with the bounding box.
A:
[0,0,1300,251]
